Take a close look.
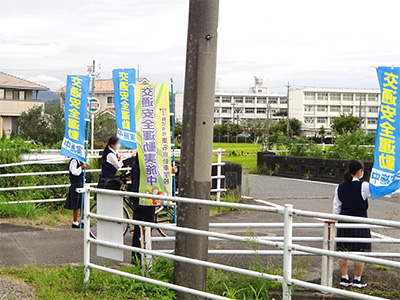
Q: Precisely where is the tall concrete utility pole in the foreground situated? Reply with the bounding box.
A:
[175,0,219,300]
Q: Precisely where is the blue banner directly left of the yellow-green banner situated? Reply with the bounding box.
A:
[113,69,137,149]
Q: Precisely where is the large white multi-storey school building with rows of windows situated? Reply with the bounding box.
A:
[175,77,380,137]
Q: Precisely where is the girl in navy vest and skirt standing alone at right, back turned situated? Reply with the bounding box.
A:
[333,159,371,289]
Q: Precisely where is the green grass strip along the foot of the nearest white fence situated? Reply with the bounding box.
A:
[0,258,296,300]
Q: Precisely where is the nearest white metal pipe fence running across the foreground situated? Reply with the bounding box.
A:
[82,185,400,300]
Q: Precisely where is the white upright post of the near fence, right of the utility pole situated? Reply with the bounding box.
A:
[283,204,293,300]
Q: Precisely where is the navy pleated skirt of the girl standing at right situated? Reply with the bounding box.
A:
[336,222,371,252]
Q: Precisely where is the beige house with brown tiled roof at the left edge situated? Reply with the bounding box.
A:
[0,72,49,137]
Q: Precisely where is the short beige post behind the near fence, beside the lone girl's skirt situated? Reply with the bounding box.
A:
[321,221,335,287]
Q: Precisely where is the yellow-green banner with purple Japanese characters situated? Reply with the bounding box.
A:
[135,84,172,205]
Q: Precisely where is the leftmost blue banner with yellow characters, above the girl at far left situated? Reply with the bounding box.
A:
[60,75,90,162]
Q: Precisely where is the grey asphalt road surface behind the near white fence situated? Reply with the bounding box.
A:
[0,175,400,286]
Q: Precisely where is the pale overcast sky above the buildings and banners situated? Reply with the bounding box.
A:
[0,0,400,92]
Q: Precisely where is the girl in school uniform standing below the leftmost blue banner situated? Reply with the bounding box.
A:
[64,158,87,228]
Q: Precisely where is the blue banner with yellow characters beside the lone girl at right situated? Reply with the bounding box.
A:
[370,67,400,199]
